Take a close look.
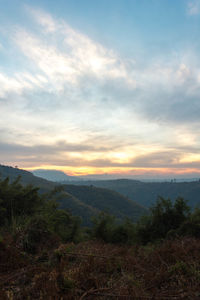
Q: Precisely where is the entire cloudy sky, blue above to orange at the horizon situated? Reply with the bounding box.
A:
[0,0,200,178]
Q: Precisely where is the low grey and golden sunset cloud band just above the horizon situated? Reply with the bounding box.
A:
[0,140,200,172]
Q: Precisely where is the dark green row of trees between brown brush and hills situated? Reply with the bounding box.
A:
[0,178,200,253]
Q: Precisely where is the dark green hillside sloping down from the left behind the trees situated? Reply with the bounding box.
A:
[0,165,148,225]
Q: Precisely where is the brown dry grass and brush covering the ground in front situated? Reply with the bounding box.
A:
[0,238,200,300]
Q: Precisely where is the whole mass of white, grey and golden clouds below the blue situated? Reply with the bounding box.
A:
[0,7,200,175]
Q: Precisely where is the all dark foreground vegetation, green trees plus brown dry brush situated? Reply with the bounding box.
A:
[0,178,200,300]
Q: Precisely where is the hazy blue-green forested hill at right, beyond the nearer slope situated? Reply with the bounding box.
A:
[63,179,200,207]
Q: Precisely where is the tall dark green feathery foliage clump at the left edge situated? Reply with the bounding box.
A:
[0,178,81,245]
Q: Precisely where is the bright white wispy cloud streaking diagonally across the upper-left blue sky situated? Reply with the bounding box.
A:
[15,8,135,90]
